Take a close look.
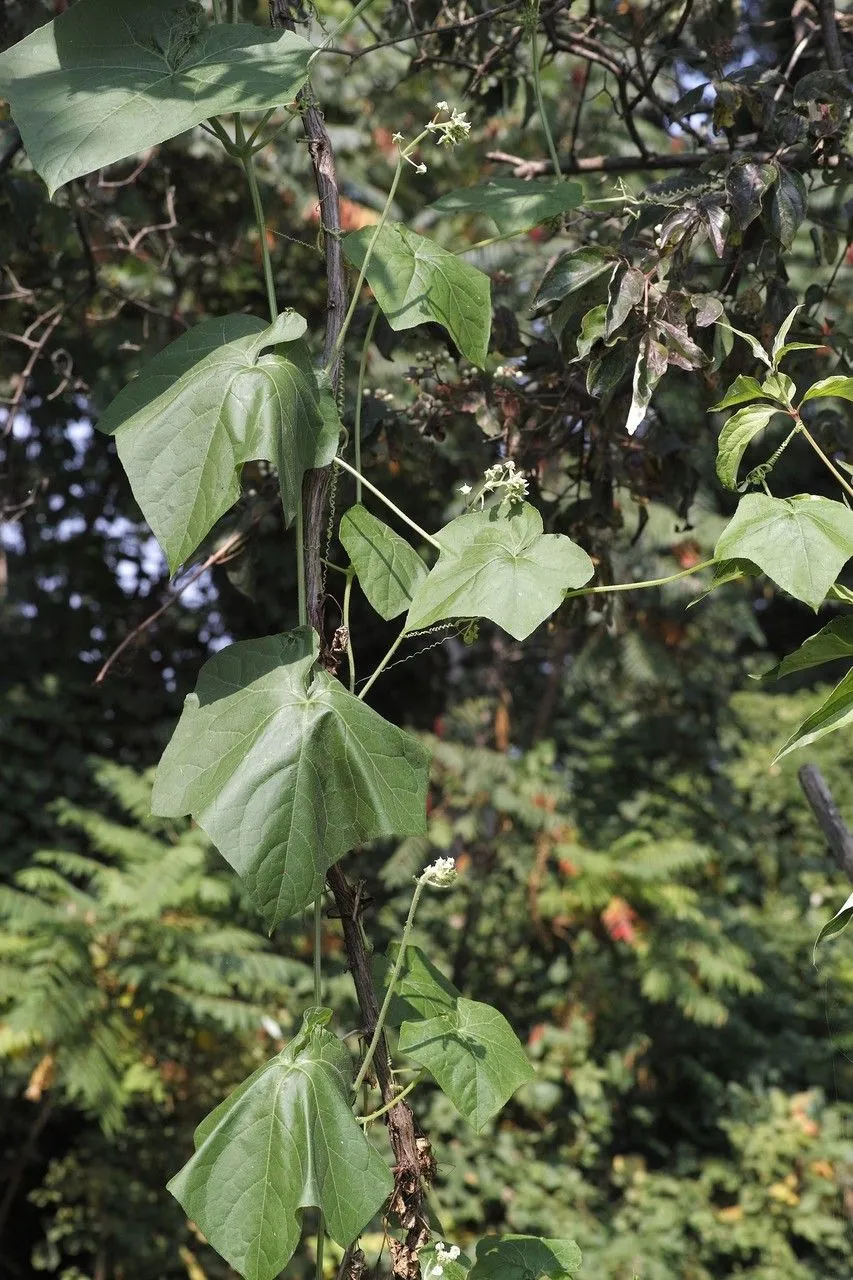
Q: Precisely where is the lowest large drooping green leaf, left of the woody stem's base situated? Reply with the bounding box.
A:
[169,1010,393,1280]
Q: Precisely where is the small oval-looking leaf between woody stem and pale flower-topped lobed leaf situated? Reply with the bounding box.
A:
[338,504,427,621]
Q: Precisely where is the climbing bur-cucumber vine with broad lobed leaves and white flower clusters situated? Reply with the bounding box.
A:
[0,0,853,1280]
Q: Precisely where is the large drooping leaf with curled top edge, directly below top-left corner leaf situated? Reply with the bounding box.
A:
[99,311,326,571]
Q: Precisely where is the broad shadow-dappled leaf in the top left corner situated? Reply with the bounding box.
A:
[0,0,314,195]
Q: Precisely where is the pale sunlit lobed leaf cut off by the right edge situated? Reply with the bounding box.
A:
[713,493,853,609]
